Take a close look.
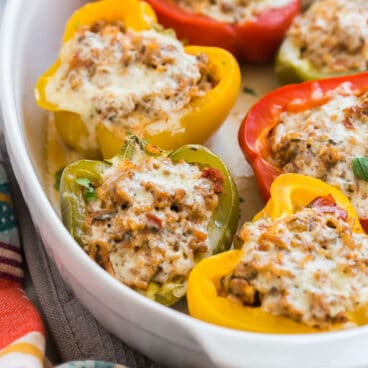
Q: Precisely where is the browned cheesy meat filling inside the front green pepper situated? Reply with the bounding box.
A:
[83,157,223,290]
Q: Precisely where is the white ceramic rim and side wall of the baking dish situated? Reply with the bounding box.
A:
[0,0,368,368]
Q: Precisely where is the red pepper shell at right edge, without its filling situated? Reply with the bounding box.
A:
[238,72,368,231]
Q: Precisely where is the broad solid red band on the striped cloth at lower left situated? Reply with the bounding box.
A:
[0,281,44,350]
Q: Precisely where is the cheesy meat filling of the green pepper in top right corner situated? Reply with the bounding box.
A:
[288,0,368,73]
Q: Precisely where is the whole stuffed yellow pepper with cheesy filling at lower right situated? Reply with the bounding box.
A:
[187,174,368,333]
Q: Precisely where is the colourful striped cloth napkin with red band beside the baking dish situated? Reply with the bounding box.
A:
[0,153,126,368]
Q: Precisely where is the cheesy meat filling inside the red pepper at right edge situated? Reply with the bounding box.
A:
[268,84,368,218]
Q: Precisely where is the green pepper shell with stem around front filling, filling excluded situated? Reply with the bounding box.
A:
[60,136,239,305]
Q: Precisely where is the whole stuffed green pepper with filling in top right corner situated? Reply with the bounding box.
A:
[276,0,368,83]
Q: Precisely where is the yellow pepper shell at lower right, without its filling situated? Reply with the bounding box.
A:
[187,174,368,334]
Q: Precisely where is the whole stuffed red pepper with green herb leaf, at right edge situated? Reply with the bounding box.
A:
[239,73,368,230]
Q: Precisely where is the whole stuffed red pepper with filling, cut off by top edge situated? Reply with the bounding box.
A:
[147,0,301,62]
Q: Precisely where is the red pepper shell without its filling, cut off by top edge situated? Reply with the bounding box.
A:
[146,0,301,63]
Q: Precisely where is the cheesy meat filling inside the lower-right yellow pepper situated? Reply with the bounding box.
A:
[221,198,368,328]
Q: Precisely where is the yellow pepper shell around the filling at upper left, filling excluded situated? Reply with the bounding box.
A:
[35,0,241,158]
